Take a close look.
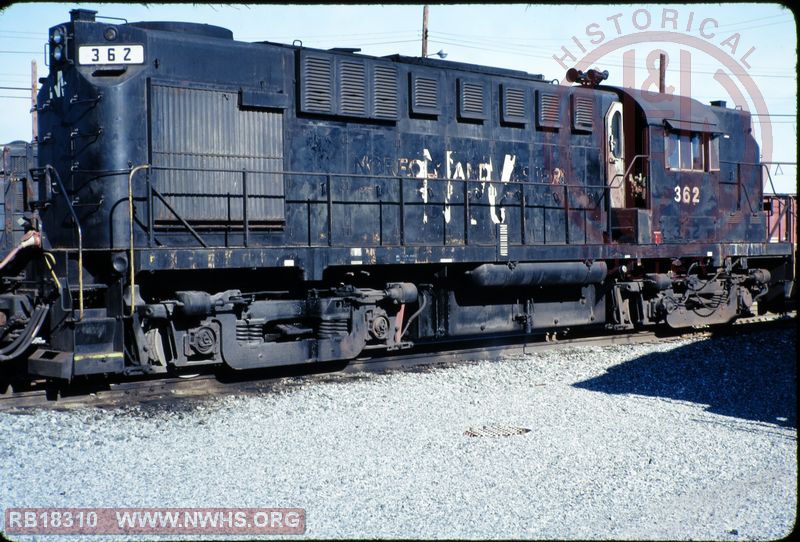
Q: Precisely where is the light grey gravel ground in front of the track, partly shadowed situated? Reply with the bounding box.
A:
[0,330,797,540]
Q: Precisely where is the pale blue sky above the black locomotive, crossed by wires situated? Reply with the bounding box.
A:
[0,3,797,193]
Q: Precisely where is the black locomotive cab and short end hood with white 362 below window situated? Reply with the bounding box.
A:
[606,88,764,249]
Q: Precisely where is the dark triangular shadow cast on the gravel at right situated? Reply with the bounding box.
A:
[573,329,797,427]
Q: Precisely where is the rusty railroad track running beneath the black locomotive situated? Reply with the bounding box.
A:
[0,312,797,413]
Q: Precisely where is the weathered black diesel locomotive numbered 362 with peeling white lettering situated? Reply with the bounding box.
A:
[0,9,795,381]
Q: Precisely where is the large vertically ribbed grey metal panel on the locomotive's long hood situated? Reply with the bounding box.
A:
[151,84,284,223]
